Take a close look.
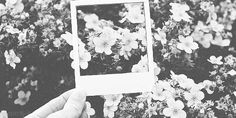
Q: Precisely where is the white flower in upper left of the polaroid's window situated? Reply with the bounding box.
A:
[84,14,100,30]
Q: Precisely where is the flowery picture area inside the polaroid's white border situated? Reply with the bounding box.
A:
[73,2,149,75]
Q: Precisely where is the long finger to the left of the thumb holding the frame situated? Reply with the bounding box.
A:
[25,89,75,118]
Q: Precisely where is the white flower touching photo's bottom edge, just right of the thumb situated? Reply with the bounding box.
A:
[103,104,118,118]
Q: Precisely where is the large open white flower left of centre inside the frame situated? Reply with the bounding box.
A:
[93,27,116,55]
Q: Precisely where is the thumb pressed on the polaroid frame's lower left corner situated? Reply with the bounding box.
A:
[63,89,86,118]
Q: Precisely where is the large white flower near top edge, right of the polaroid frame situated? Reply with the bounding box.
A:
[170,3,191,22]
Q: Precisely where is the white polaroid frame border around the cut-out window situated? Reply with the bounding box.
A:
[70,0,155,96]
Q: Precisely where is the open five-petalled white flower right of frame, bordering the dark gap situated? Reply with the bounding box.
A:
[177,35,198,53]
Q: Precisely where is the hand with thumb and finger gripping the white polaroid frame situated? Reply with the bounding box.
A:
[25,89,88,118]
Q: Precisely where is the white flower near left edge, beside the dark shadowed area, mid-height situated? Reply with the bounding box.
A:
[4,49,20,69]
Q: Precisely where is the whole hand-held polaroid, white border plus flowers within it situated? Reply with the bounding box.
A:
[70,0,155,96]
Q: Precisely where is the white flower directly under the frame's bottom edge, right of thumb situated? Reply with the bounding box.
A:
[104,94,123,106]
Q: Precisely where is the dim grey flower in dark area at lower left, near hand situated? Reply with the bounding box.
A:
[14,90,31,106]
